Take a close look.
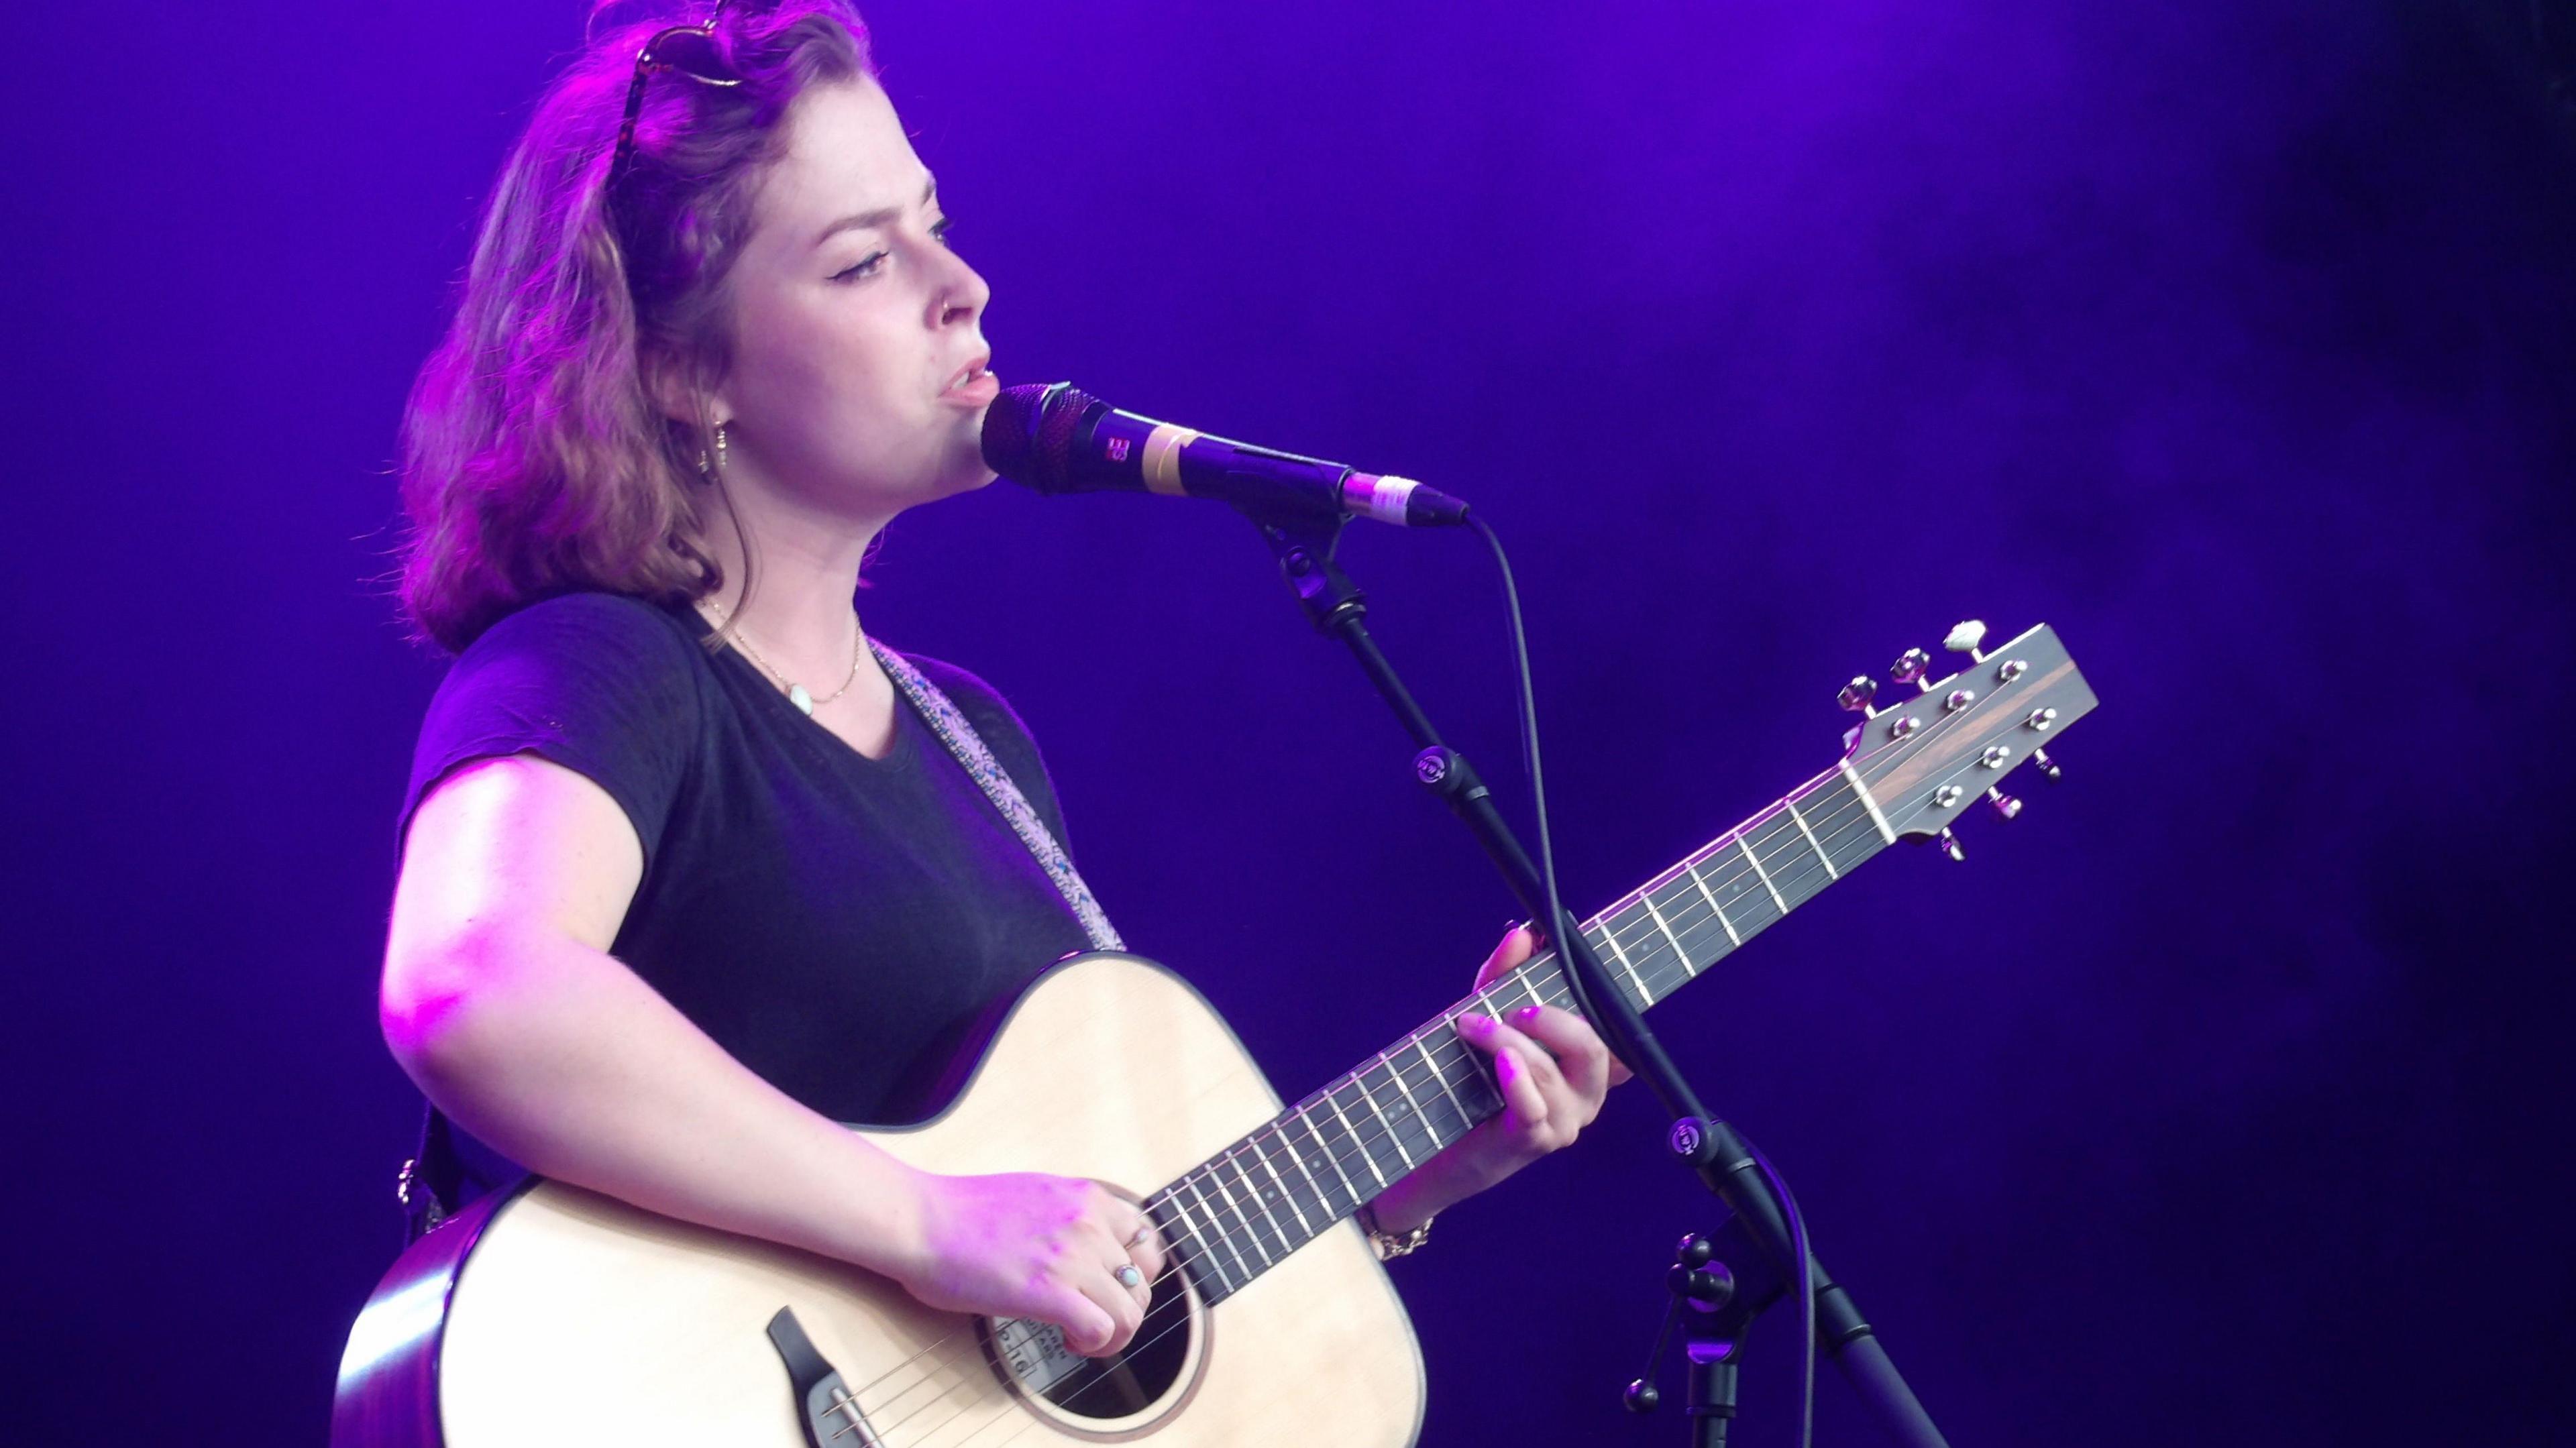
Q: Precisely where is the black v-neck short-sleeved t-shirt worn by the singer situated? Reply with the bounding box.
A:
[402,593,1087,1126]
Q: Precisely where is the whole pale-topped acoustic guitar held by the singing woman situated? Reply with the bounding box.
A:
[332,626,2094,1448]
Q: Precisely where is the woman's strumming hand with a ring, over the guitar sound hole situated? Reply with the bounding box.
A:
[899,1172,1165,1358]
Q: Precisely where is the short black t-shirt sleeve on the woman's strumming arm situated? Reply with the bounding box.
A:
[396,593,706,871]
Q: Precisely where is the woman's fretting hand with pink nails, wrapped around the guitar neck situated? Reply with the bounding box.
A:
[1373,925,1628,1234]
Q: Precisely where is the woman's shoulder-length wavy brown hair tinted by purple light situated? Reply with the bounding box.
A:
[402,0,876,652]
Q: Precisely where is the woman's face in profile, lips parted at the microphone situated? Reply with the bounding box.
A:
[714,80,1000,520]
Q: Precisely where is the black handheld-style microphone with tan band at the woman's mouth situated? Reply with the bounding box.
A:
[984,382,1466,528]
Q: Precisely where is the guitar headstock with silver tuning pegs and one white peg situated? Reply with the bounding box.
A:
[1842,621,2097,860]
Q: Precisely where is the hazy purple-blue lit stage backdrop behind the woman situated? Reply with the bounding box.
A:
[0,0,2576,1445]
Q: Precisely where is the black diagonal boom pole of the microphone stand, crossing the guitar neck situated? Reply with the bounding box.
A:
[1236,502,1947,1448]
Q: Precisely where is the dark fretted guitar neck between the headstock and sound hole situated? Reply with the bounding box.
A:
[1146,765,1896,1304]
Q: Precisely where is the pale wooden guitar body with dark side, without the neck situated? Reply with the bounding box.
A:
[332,956,1425,1448]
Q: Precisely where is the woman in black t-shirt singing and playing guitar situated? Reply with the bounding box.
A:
[384,0,1613,1355]
